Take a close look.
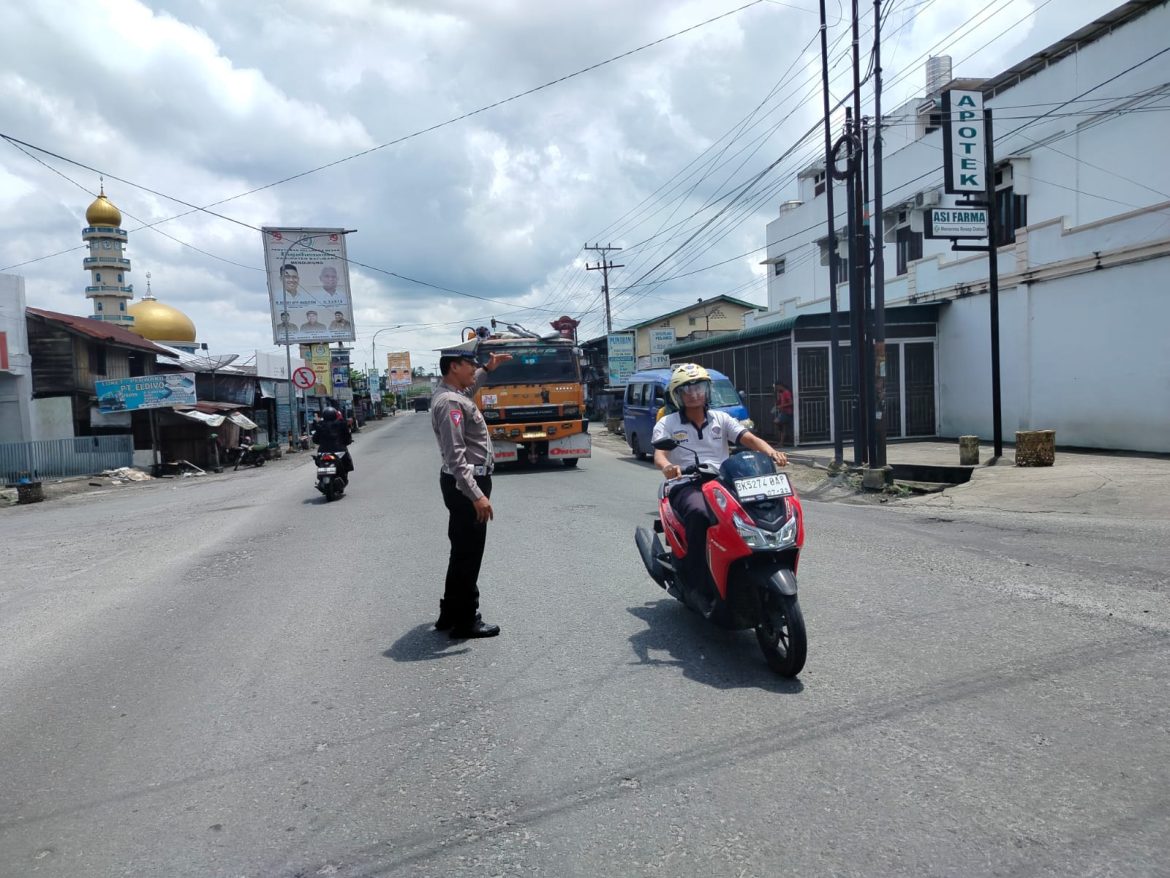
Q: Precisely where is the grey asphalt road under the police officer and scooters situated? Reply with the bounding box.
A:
[0,414,1170,878]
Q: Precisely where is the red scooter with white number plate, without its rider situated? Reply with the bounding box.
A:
[634,438,808,677]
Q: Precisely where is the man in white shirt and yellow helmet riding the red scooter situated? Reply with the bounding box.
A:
[652,363,789,597]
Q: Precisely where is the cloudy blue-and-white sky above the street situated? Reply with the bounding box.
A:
[0,0,1120,369]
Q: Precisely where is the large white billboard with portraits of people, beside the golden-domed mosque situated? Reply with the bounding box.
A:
[261,226,355,344]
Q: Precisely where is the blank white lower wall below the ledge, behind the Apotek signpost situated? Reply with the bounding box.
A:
[938,250,1170,453]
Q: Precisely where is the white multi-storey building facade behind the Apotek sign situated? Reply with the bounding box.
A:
[756,0,1170,452]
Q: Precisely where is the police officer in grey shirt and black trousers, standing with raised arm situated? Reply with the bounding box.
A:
[431,339,511,639]
